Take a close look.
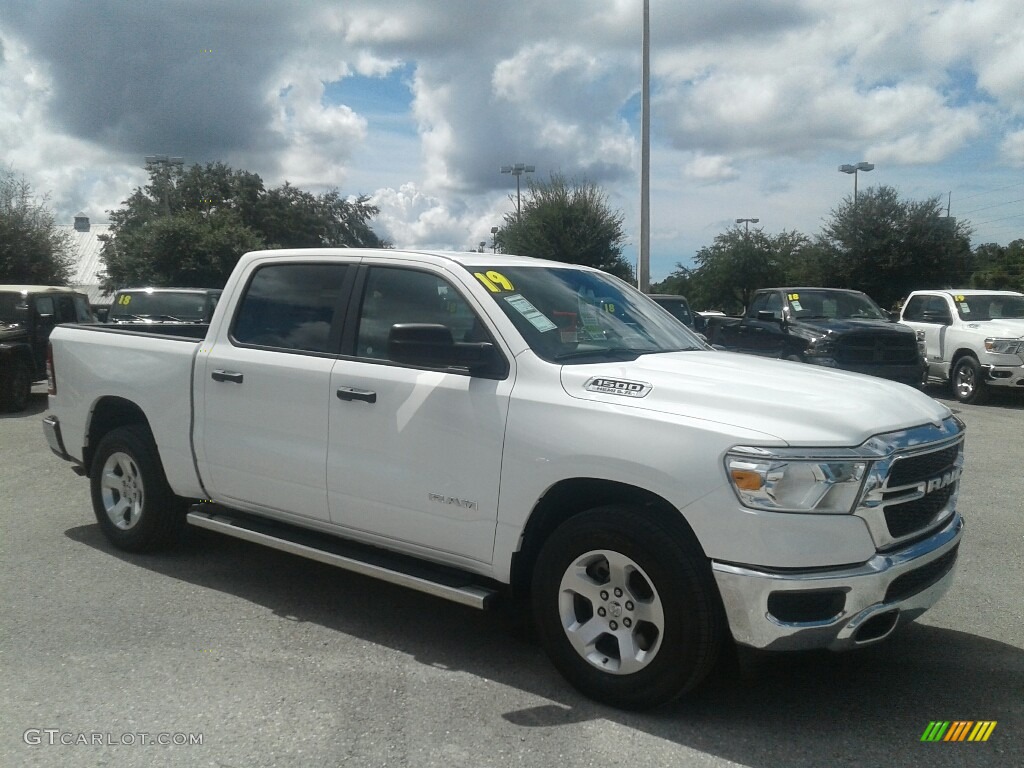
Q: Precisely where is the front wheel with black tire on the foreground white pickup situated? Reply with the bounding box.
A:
[532,505,724,710]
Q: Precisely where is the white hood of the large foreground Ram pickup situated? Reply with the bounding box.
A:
[561,351,950,446]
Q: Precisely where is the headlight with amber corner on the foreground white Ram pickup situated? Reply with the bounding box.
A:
[725,447,869,514]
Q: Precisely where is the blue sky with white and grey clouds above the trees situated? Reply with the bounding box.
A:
[0,0,1024,280]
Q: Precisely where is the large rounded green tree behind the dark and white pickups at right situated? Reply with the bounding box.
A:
[818,186,971,307]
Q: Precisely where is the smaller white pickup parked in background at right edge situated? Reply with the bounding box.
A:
[900,288,1024,403]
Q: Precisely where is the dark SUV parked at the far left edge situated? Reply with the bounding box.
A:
[0,286,96,411]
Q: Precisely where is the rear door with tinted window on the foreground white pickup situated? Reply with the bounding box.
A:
[197,257,358,521]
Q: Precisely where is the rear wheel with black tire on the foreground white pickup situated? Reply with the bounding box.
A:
[89,424,187,552]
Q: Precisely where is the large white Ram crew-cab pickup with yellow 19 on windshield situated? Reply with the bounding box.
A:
[44,249,965,709]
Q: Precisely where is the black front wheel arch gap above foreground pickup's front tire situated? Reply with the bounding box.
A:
[510,477,703,597]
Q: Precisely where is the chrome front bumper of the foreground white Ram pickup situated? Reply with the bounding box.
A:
[712,514,964,650]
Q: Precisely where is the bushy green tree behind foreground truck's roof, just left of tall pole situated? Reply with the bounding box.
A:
[495,174,635,282]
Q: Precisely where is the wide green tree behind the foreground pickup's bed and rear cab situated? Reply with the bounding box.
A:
[102,163,387,290]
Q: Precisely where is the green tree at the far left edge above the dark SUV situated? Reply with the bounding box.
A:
[0,170,74,285]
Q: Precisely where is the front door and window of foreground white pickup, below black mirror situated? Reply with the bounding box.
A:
[328,261,513,563]
